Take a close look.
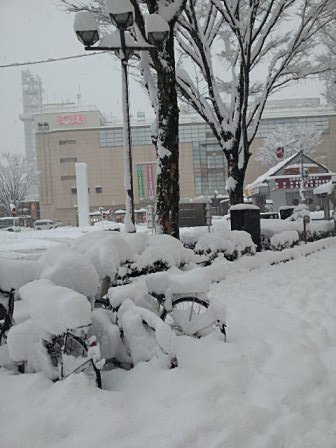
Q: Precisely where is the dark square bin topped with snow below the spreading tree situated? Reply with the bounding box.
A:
[230,204,261,252]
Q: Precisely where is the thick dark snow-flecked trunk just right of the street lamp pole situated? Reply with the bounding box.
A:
[155,29,180,238]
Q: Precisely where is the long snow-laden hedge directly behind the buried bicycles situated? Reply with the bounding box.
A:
[0,231,194,301]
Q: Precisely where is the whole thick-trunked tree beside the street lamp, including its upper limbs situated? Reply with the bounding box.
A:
[60,0,187,238]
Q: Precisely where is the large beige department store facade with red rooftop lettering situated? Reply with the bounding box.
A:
[34,100,336,225]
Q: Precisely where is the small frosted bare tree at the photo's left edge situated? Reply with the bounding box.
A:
[0,152,32,216]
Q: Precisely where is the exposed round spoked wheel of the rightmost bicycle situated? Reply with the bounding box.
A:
[161,296,214,337]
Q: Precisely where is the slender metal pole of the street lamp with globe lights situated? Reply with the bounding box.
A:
[119,29,136,233]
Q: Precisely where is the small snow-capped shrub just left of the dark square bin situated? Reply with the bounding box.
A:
[194,230,256,261]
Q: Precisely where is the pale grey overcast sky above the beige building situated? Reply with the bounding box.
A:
[0,0,321,158]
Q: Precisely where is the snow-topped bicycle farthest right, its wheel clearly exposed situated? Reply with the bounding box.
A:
[107,269,226,341]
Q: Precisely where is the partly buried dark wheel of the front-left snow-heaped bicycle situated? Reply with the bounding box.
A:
[60,334,102,389]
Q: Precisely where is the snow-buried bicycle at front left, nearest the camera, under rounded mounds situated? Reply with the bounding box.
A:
[5,280,105,388]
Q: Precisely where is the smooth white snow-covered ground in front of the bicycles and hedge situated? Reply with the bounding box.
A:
[0,228,336,448]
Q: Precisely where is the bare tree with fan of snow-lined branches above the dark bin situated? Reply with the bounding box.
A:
[176,0,334,204]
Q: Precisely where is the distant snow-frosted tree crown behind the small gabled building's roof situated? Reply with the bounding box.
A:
[255,126,322,168]
